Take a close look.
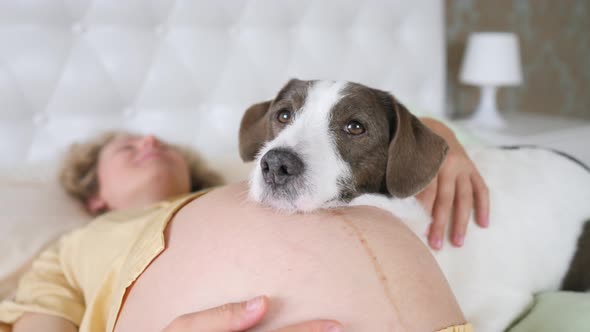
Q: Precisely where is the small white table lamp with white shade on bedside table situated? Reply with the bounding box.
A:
[460,32,522,129]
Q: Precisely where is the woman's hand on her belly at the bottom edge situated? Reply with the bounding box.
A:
[164,296,343,332]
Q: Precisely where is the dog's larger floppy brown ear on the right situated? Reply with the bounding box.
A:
[386,99,449,198]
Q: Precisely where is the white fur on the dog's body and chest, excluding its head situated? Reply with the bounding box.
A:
[351,149,590,332]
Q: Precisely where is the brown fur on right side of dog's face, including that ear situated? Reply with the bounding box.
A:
[330,83,448,199]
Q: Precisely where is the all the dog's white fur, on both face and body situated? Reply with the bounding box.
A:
[250,82,590,332]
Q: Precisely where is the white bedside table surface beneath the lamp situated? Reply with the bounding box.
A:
[454,112,590,165]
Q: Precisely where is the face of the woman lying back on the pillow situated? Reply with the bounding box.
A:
[88,135,191,212]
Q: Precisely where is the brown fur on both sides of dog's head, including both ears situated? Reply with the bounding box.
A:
[240,79,448,201]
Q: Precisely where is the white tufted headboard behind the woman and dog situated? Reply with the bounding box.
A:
[0,0,445,179]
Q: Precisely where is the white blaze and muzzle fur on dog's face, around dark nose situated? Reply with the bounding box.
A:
[250,81,350,212]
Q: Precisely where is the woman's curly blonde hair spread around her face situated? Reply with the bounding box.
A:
[59,131,223,213]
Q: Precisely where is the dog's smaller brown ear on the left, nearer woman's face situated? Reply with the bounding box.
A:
[240,100,271,161]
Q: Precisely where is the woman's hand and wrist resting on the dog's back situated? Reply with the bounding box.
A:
[417,118,490,250]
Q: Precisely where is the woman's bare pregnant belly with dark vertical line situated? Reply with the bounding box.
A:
[115,183,465,332]
